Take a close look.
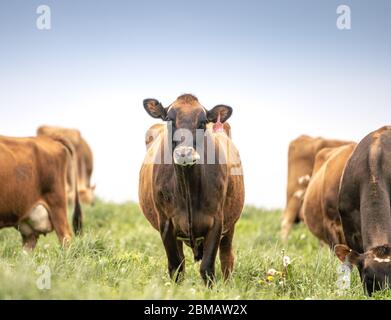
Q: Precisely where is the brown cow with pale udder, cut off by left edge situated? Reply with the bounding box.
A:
[0,136,82,249]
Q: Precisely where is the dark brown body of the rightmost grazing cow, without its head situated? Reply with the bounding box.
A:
[339,126,391,252]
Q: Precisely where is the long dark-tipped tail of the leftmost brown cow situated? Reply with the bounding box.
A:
[50,134,83,235]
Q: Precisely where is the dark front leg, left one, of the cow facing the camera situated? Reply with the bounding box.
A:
[160,220,185,282]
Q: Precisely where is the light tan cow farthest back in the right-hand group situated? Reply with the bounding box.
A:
[281,135,352,241]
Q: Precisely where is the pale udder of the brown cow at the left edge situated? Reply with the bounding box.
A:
[18,204,53,236]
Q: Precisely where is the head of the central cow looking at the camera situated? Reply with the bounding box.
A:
[144,94,232,166]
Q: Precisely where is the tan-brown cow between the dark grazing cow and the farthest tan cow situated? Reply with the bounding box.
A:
[301,144,356,248]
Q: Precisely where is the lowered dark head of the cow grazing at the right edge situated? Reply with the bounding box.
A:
[334,244,391,295]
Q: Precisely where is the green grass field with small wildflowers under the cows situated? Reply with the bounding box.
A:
[0,202,391,299]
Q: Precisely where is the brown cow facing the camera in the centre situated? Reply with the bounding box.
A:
[139,94,244,285]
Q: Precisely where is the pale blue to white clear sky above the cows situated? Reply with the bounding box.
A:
[0,0,391,207]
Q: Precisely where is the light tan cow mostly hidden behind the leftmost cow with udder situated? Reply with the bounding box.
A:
[37,125,95,204]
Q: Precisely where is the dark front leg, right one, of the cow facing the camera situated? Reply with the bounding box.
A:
[200,216,223,287]
